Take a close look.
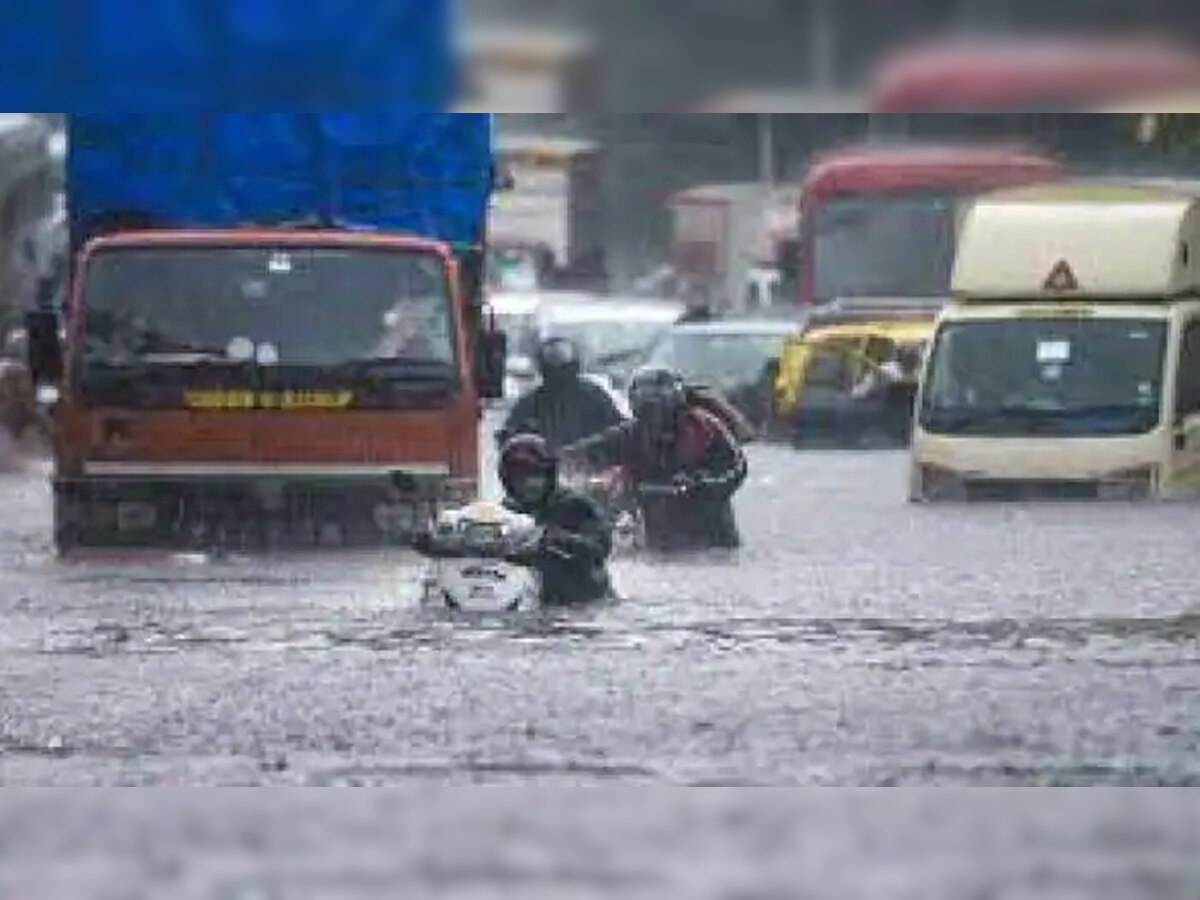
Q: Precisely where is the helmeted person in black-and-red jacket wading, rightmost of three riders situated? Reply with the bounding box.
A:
[563,368,748,551]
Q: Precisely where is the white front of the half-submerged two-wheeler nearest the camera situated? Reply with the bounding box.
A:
[421,502,542,613]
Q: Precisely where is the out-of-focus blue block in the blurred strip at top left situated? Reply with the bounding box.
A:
[0,0,456,113]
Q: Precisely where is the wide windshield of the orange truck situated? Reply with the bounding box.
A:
[84,246,455,367]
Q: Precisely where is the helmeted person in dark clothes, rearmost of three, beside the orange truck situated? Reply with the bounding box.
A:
[497,337,625,452]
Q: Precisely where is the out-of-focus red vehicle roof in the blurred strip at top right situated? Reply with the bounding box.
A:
[871,38,1200,114]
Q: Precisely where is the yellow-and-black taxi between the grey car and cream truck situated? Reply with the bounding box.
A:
[775,299,942,448]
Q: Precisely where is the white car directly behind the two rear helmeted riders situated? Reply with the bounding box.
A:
[538,294,688,392]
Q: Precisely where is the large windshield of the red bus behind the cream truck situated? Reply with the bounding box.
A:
[812,193,959,301]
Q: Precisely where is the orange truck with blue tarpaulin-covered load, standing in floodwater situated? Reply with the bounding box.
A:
[28,112,505,552]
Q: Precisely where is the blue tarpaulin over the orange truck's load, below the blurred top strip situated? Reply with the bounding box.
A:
[67,112,492,245]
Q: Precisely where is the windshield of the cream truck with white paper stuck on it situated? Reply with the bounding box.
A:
[920,318,1166,437]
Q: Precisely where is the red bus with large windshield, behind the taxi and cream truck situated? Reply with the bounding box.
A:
[799,144,1066,305]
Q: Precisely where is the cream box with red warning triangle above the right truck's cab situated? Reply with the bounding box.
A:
[952,182,1200,301]
